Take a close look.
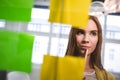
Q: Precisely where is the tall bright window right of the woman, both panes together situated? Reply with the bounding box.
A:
[104,15,120,73]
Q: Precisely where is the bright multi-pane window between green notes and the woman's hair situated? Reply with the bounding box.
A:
[27,8,71,64]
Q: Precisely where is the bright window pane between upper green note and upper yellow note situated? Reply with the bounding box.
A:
[27,8,50,32]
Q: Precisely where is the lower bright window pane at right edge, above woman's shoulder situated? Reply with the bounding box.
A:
[104,43,120,73]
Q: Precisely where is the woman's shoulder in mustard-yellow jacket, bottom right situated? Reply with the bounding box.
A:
[95,67,115,80]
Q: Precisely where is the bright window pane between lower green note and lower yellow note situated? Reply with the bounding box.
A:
[32,36,48,64]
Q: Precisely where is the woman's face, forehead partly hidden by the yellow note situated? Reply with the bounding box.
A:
[76,19,98,55]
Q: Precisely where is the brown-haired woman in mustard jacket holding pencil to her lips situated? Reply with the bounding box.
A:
[66,16,115,80]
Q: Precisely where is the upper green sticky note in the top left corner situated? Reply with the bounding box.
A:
[0,0,33,22]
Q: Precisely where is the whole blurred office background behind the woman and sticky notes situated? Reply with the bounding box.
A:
[0,0,120,80]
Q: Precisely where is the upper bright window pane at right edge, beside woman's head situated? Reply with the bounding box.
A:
[106,15,120,39]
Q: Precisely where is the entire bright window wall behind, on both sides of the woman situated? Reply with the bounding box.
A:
[0,8,120,80]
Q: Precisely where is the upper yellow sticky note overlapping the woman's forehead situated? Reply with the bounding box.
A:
[49,0,91,28]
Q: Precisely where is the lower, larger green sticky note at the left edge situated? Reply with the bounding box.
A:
[0,30,34,73]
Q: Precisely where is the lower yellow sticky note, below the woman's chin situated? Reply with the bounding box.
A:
[40,55,85,80]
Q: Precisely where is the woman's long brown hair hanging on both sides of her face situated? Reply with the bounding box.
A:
[66,16,103,69]
